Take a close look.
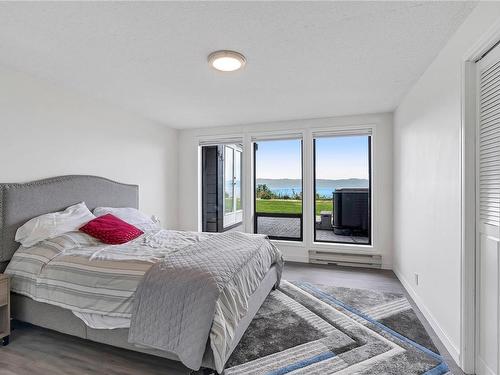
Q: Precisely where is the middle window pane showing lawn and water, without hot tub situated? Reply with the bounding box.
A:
[254,139,302,241]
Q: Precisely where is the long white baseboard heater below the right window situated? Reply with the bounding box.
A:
[309,250,382,268]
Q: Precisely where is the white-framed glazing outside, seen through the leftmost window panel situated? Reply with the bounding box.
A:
[224,145,243,228]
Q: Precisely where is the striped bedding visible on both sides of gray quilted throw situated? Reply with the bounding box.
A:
[5,230,282,369]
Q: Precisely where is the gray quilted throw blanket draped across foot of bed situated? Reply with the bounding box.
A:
[129,232,283,372]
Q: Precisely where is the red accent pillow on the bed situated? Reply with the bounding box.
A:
[80,214,144,245]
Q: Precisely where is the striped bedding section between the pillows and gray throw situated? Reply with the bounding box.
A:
[5,230,210,318]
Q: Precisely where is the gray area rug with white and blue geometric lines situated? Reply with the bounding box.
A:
[210,281,450,375]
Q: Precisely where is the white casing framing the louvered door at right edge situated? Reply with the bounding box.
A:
[457,21,500,373]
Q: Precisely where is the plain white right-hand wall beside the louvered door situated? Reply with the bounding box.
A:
[394,2,500,361]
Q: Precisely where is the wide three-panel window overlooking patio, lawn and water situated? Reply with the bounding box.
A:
[199,126,376,250]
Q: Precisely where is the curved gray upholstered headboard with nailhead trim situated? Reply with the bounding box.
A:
[0,175,139,271]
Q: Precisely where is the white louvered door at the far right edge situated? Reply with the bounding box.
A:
[476,42,500,375]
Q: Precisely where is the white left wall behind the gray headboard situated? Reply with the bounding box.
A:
[0,67,177,227]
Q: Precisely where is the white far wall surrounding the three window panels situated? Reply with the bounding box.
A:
[178,114,393,268]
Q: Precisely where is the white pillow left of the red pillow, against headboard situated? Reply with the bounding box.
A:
[16,202,95,247]
